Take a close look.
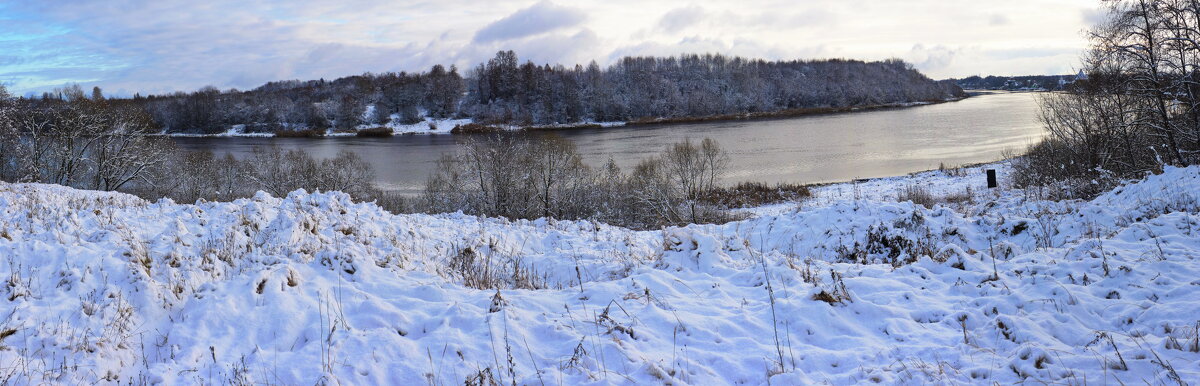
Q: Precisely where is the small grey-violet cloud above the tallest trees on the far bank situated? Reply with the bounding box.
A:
[474,1,587,43]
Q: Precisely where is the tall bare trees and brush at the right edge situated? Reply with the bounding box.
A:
[1018,0,1200,195]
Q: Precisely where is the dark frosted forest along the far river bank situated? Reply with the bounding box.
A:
[22,50,964,134]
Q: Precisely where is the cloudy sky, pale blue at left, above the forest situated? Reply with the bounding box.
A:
[0,0,1103,96]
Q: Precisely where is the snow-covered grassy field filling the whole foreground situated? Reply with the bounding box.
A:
[0,164,1200,385]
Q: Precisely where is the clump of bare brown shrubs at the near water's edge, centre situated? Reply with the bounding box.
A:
[420,135,732,228]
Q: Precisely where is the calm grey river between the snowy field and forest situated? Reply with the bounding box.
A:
[175,92,1045,193]
